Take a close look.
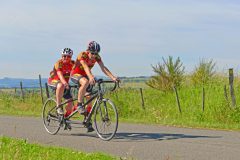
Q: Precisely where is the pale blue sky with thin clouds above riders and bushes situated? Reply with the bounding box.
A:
[0,0,240,78]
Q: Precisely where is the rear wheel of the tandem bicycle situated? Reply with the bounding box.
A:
[42,98,63,134]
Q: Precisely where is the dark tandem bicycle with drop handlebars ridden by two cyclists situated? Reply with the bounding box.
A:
[42,79,119,141]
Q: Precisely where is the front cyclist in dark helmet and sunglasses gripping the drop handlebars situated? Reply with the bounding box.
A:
[71,41,118,132]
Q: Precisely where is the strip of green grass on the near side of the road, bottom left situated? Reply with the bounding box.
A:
[0,136,120,160]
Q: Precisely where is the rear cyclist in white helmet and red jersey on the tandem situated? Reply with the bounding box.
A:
[48,48,74,116]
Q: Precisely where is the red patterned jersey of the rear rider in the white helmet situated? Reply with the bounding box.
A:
[50,59,74,82]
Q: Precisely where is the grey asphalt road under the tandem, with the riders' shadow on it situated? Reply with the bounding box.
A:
[0,116,240,160]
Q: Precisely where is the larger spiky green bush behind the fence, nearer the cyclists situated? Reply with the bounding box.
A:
[146,56,185,91]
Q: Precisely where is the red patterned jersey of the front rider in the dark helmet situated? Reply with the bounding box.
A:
[71,51,101,76]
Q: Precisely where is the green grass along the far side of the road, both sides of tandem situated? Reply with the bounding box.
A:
[0,78,240,130]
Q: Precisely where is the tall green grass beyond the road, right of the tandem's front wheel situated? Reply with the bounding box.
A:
[109,80,240,130]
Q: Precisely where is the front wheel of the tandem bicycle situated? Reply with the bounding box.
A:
[94,99,118,141]
